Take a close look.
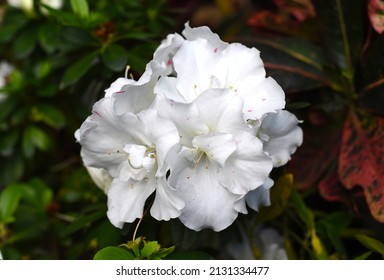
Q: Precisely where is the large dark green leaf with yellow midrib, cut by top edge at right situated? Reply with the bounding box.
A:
[313,0,365,73]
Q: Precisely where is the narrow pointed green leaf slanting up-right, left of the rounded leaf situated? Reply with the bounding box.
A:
[61,52,97,88]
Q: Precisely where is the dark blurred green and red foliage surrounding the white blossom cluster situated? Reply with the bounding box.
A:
[0,0,384,259]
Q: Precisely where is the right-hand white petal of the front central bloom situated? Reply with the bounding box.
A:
[219,132,272,195]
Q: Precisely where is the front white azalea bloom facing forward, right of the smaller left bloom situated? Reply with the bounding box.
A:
[154,89,272,231]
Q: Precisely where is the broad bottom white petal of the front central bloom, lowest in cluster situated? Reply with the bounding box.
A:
[170,161,239,231]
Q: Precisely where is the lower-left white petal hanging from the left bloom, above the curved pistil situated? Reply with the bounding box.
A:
[107,179,156,228]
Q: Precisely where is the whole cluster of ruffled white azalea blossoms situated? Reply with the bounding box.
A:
[75,24,303,231]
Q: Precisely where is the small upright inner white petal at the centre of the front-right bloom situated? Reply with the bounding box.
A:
[192,132,237,167]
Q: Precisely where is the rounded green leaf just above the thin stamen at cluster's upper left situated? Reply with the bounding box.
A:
[101,44,128,72]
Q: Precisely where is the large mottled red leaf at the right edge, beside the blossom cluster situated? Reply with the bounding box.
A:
[338,110,384,223]
